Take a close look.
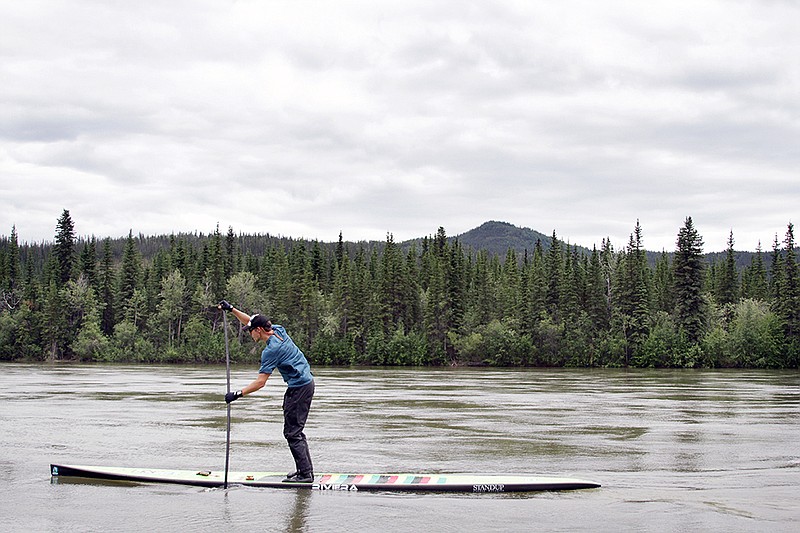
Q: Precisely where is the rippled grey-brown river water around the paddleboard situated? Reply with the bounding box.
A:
[0,364,800,533]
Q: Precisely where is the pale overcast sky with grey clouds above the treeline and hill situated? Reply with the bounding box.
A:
[0,0,800,251]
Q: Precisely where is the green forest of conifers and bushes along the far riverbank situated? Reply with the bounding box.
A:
[0,209,800,368]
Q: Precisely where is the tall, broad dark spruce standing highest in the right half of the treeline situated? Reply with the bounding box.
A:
[673,217,706,343]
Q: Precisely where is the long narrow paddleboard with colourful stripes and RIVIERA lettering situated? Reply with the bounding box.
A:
[50,464,600,493]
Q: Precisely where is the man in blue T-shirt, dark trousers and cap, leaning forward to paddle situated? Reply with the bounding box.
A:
[219,300,314,483]
